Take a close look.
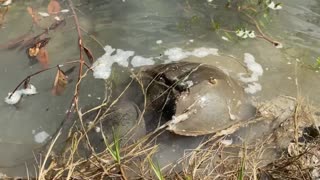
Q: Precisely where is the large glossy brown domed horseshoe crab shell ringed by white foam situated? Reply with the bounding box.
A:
[141,62,255,136]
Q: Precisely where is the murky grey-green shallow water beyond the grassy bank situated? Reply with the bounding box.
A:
[0,0,320,174]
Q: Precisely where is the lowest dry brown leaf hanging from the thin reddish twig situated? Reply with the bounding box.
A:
[51,69,68,95]
